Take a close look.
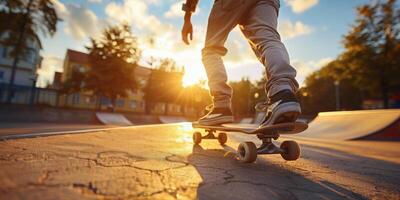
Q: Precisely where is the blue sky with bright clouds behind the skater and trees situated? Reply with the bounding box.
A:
[38,0,370,86]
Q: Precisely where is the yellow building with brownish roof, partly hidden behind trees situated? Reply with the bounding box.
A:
[56,49,197,116]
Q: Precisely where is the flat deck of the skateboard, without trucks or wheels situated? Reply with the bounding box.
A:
[192,122,308,135]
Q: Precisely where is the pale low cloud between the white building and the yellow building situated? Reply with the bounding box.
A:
[37,55,63,87]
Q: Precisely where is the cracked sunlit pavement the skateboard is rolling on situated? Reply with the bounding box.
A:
[0,123,400,199]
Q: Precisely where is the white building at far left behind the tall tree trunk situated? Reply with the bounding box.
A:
[0,33,42,104]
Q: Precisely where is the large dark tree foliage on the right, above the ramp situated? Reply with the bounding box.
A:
[300,0,400,114]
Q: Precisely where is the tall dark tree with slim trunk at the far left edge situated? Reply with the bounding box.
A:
[0,0,60,103]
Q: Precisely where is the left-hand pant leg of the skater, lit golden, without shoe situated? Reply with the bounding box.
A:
[202,0,248,107]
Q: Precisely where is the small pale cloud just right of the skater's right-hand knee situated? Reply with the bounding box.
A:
[278,21,313,39]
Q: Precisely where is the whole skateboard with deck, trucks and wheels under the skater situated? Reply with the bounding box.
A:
[192,121,308,163]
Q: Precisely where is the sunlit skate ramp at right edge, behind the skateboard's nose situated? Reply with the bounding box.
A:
[299,109,400,140]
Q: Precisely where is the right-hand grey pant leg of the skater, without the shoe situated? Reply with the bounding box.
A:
[240,0,298,97]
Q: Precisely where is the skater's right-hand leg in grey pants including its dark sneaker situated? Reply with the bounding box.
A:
[240,0,301,126]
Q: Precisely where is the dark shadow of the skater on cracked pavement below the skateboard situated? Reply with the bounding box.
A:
[188,145,366,200]
